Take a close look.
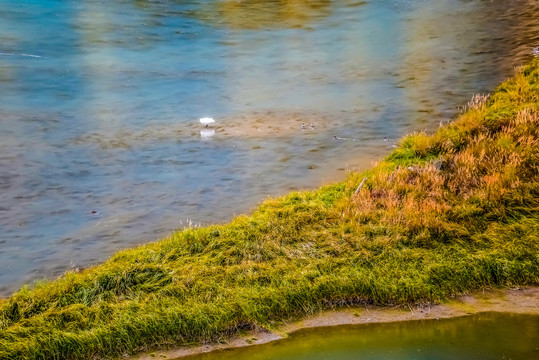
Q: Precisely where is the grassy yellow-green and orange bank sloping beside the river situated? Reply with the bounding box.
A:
[0,59,539,359]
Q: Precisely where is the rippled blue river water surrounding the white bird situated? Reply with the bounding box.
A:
[0,0,539,296]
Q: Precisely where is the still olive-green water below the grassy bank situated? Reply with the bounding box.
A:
[182,313,539,360]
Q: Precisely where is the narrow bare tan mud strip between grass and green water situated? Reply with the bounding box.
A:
[132,287,539,360]
